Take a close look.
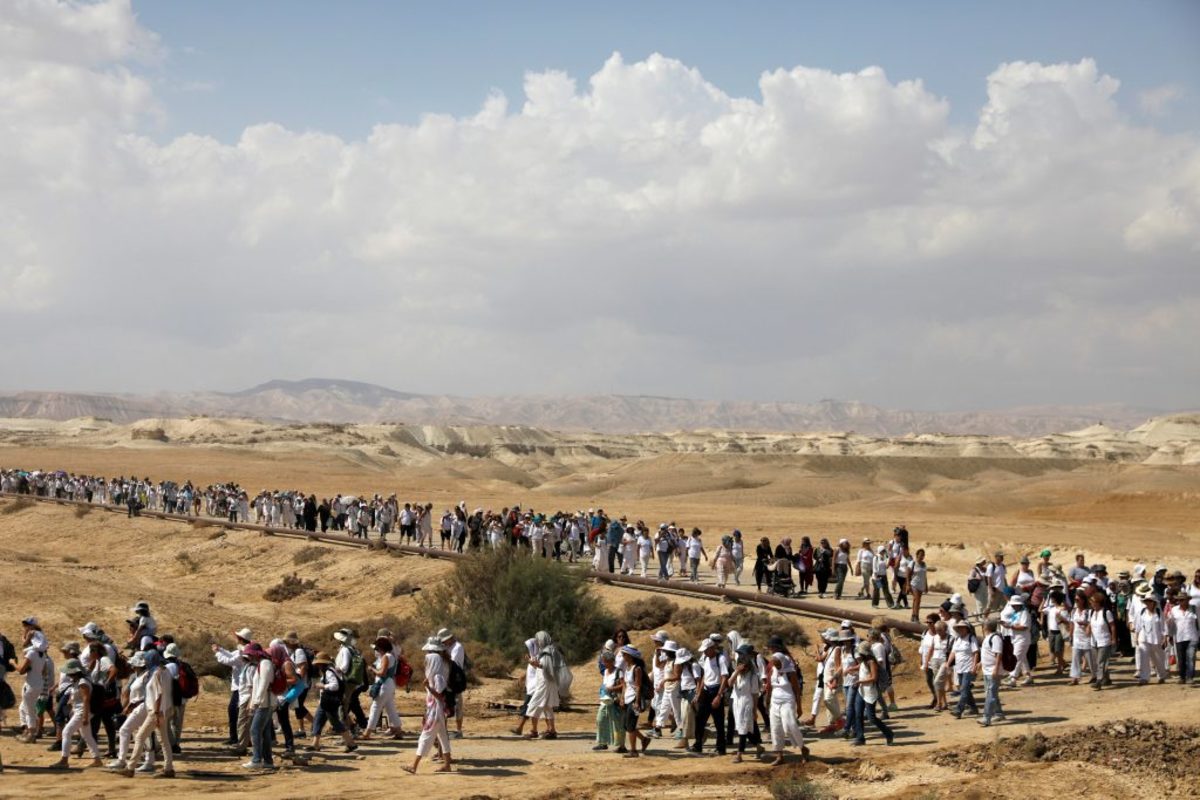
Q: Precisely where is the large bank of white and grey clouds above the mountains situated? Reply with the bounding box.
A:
[0,0,1200,407]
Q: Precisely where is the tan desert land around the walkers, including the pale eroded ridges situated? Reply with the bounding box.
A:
[0,416,1200,798]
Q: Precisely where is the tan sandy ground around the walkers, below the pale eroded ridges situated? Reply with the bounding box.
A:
[0,445,1200,798]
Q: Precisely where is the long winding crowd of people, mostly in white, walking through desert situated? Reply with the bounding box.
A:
[0,462,1200,776]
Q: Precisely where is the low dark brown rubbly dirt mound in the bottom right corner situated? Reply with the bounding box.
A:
[929,720,1200,790]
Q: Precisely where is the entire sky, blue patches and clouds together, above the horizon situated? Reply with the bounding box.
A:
[0,0,1200,409]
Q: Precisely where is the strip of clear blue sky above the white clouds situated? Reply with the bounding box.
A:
[142,0,1200,142]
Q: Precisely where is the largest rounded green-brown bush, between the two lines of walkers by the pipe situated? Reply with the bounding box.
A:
[421,548,614,666]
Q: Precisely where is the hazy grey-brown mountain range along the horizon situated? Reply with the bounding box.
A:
[0,378,1176,438]
